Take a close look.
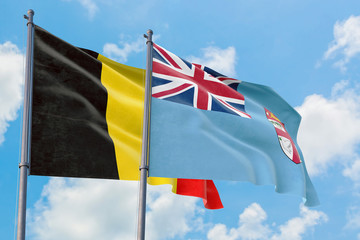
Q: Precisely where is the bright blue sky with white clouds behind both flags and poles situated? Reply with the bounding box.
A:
[0,0,360,240]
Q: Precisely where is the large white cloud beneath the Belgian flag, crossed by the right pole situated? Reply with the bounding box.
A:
[29,178,201,240]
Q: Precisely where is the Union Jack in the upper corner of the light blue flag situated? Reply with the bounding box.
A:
[152,44,251,118]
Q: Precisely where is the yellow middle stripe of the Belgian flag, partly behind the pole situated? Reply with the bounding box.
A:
[98,54,177,193]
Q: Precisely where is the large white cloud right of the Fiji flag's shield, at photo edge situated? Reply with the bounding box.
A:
[296,81,360,176]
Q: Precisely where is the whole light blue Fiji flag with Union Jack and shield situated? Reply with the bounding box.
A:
[149,44,318,206]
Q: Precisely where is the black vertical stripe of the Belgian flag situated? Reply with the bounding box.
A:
[30,26,119,179]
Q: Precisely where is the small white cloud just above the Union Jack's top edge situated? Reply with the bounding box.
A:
[187,46,236,77]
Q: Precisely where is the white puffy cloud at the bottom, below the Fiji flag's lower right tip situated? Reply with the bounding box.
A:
[207,203,328,240]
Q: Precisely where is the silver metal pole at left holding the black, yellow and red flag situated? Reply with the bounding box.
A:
[17,9,34,240]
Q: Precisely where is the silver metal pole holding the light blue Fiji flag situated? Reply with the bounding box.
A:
[137,29,153,240]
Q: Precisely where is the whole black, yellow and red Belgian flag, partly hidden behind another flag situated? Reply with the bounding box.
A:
[30,26,222,209]
